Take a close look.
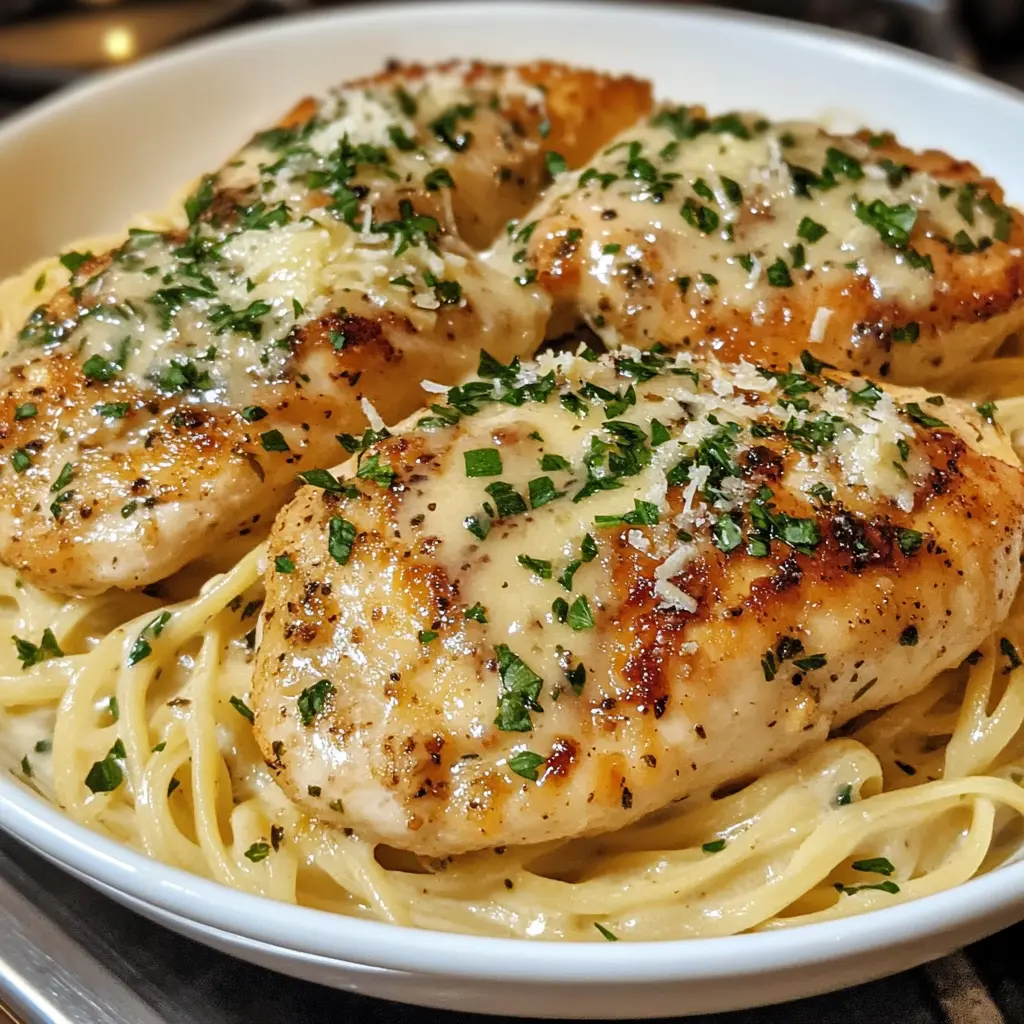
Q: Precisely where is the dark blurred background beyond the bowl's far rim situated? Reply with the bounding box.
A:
[0,0,1024,117]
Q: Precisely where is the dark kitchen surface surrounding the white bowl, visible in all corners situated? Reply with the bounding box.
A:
[0,0,1024,1024]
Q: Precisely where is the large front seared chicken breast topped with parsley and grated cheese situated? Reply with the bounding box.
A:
[253,350,1024,856]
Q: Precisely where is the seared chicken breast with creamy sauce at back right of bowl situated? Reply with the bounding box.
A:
[494,106,1024,386]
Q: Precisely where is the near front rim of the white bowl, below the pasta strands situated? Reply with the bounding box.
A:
[6,778,1024,985]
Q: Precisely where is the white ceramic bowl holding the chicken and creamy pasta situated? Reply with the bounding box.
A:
[0,3,1024,1018]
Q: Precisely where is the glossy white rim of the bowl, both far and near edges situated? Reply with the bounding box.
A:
[0,0,1024,985]
